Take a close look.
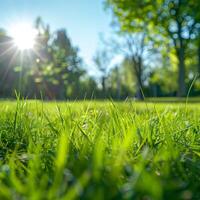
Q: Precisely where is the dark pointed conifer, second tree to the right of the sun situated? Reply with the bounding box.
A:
[52,29,85,98]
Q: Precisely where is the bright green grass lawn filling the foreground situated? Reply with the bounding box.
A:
[0,100,200,200]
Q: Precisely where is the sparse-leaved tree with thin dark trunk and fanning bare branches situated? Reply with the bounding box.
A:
[105,28,155,100]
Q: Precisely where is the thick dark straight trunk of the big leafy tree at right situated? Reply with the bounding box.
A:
[177,45,186,97]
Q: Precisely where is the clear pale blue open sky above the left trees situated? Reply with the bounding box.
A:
[0,0,111,74]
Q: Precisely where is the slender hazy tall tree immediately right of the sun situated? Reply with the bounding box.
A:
[33,17,56,99]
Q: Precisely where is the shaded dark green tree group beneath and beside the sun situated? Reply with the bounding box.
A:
[0,17,99,99]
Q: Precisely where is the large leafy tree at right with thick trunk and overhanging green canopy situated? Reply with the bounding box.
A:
[107,0,200,96]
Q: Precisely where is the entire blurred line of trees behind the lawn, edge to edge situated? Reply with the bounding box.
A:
[0,0,200,100]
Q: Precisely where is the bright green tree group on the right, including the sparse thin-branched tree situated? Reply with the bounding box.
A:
[106,0,200,98]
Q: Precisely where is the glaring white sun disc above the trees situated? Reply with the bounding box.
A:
[10,22,37,51]
